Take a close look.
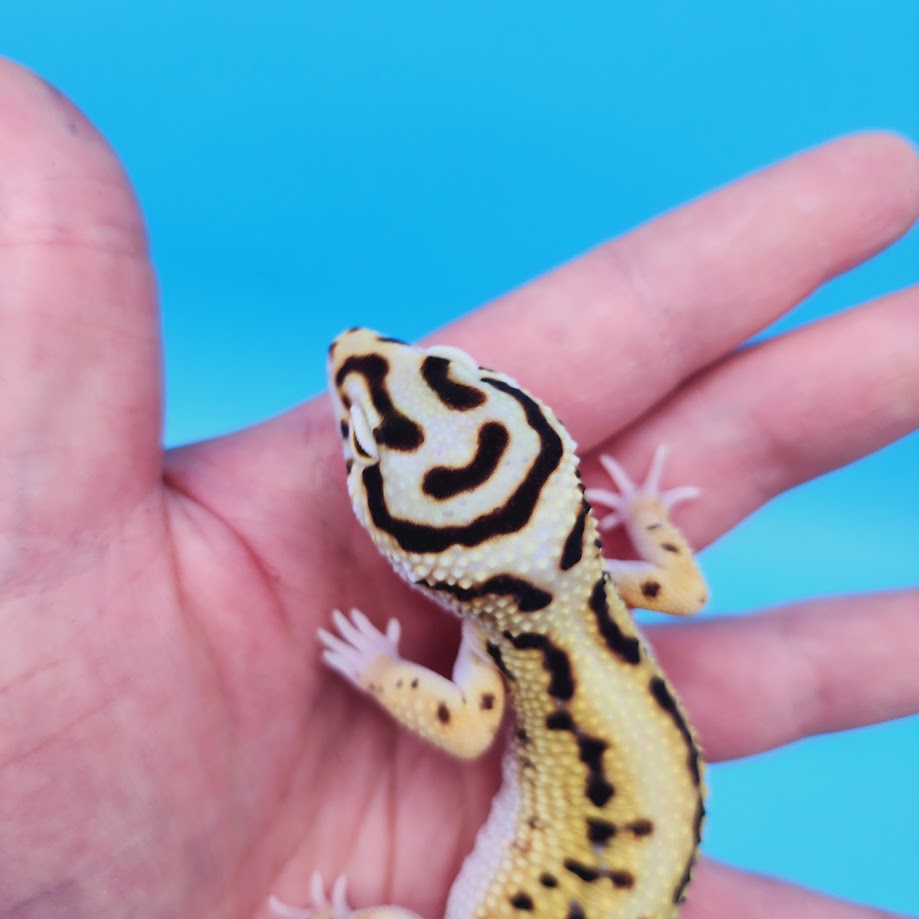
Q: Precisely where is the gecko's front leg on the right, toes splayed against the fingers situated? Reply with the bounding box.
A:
[586,444,708,616]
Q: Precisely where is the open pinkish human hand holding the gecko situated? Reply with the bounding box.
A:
[0,57,919,919]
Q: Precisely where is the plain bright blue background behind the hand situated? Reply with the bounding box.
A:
[0,0,919,913]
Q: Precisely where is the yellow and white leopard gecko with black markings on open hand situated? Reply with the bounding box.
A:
[273,329,706,919]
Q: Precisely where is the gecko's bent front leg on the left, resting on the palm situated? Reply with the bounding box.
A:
[319,610,505,759]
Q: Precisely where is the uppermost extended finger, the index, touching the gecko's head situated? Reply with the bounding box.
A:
[436,134,919,451]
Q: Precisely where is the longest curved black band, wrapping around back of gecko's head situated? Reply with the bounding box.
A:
[362,376,565,552]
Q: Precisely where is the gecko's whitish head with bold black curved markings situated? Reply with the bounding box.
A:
[329,329,573,583]
